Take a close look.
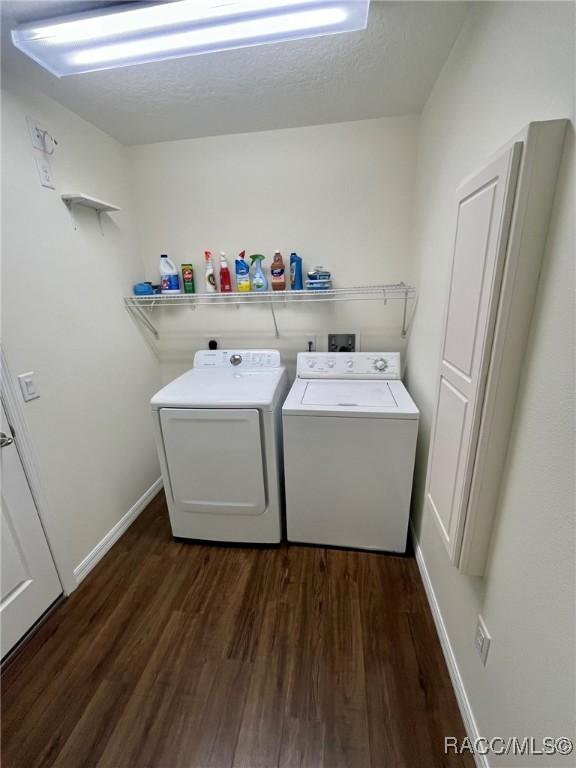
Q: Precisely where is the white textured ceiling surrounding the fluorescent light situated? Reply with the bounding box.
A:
[2,0,466,144]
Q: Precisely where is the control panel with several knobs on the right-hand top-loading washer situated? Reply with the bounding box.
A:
[297,352,402,379]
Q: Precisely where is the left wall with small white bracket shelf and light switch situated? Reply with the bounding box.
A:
[2,85,159,580]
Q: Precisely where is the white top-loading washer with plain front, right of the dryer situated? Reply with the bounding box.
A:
[282,352,419,552]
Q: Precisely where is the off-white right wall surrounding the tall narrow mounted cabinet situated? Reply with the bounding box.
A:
[408,2,575,766]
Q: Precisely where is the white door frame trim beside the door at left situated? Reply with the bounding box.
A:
[0,345,78,595]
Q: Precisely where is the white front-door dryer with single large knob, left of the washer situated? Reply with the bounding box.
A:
[151,350,288,543]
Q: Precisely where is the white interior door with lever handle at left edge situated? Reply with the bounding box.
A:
[0,406,62,656]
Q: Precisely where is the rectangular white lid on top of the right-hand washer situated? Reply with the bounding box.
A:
[301,380,398,408]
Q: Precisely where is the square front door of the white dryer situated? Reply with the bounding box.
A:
[160,408,266,515]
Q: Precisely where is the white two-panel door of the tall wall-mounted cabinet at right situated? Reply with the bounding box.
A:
[426,142,522,564]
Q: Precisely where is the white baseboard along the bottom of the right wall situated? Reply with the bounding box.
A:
[410,526,490,768]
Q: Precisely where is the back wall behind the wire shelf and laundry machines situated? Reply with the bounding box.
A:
[128,116,418,378]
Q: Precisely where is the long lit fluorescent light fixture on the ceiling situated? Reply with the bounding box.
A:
[12,0,370,77]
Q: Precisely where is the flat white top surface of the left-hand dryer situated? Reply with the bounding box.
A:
[151,368,286,409]
